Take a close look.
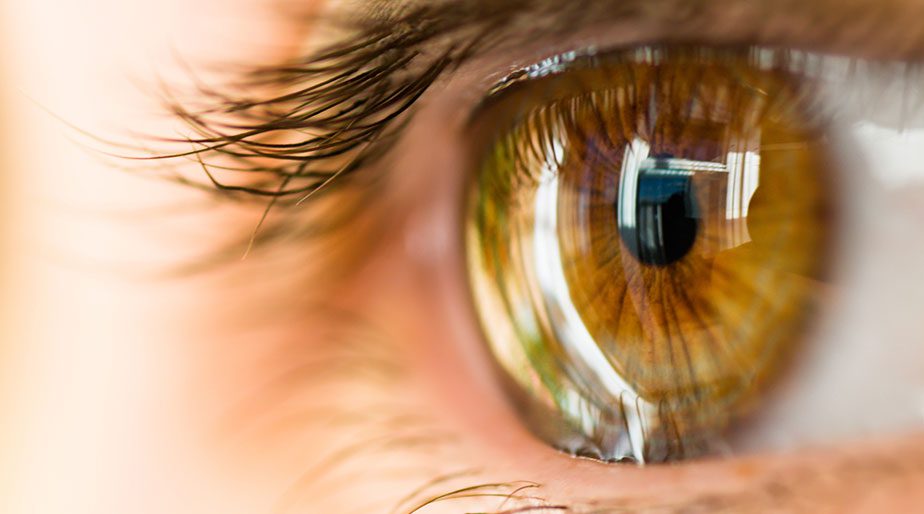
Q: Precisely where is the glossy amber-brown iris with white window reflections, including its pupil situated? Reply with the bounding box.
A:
[467,47,834,462]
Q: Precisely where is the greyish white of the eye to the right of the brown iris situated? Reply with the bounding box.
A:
[733,65,924,450]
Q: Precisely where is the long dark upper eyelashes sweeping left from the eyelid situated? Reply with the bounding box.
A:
[79,0,540,260]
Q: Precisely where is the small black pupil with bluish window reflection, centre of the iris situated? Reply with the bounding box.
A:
[615,156,698,266]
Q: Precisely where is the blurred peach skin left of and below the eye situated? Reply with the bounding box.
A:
[0,0,924,514]
